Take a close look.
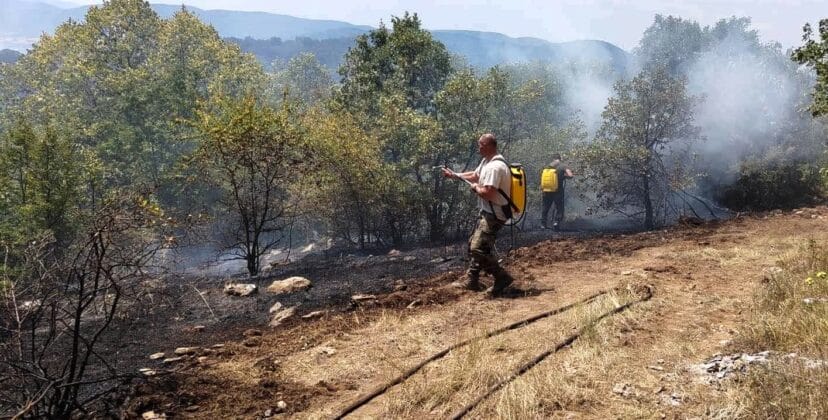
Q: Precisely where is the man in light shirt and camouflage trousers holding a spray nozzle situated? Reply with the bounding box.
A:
[443,133,513,296]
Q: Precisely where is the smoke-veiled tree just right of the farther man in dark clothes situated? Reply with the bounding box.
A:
[578,68,699,229]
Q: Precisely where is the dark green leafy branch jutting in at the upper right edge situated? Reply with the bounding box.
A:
[791,19,828,116]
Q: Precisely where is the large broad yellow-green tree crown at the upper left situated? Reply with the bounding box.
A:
[0,0,264,202]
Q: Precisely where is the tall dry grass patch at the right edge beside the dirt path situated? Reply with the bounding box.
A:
[737,240,828,419]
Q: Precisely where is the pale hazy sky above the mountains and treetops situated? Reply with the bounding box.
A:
[76,0,828,50]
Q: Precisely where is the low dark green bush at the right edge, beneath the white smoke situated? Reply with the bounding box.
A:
[717,159,825,210]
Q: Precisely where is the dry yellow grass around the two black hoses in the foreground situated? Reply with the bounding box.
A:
[376,292,648,419]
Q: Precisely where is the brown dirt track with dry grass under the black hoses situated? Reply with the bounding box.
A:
[125,207,828,419]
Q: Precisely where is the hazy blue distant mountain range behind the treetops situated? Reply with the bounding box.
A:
[0,0,630,71]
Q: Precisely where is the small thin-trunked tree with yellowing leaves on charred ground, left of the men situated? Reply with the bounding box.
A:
[193,96,309,276]
